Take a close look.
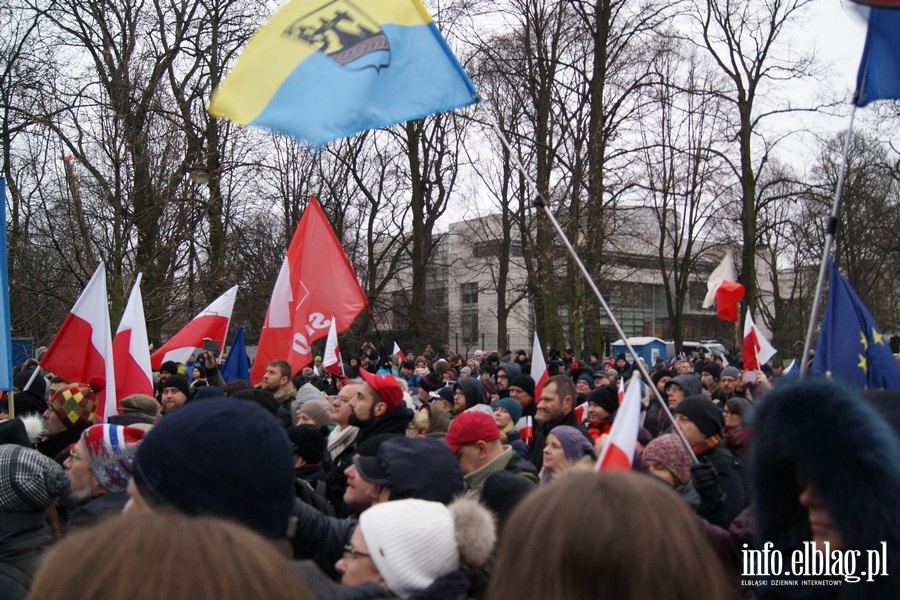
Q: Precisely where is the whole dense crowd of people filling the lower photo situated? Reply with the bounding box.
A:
[0,345,900,600]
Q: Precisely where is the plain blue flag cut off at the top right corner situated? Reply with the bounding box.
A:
[854,0,900,106]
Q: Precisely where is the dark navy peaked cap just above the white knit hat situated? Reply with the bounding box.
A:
[353,434,464,504]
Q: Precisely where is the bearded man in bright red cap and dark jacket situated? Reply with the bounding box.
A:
[348,369,412,442]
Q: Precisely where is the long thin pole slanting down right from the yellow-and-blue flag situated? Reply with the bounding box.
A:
[482,101,700,462]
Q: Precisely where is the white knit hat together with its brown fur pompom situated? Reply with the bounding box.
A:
[359,499,497,598]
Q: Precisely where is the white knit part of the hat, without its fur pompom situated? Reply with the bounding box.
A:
[359,499,459,598]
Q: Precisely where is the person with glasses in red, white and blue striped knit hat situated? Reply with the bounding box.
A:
[63,425,146,527]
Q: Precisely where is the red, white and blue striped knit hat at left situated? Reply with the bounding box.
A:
[81,422,146,493]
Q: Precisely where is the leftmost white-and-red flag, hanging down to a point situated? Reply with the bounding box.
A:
[41,262,118,422]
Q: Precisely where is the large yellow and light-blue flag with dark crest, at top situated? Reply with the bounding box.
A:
[209,0,478,146]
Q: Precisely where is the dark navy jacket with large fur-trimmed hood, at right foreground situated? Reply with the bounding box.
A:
[750,379,900,599]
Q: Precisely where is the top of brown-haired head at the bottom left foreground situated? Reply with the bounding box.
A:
[28,511,312,600]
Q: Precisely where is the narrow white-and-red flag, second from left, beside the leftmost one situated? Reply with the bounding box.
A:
[113,273,153,400]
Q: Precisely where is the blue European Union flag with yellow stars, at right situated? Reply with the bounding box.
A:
[812,260,900,390]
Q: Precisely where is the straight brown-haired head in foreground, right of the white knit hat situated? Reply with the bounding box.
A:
[487,471,733,600]
